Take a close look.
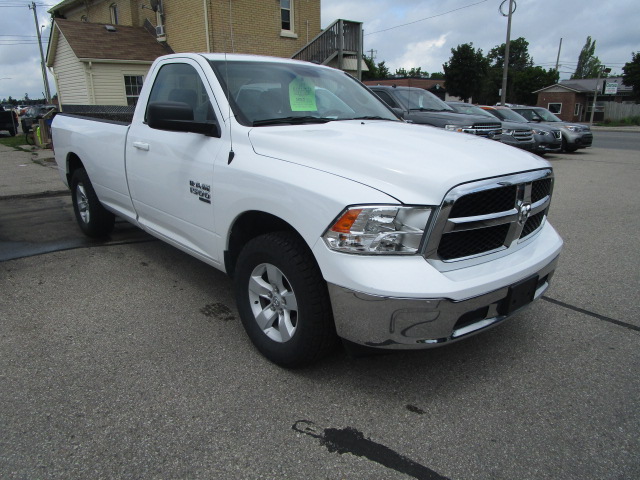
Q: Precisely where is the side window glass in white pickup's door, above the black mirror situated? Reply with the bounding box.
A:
[145,63,216,122]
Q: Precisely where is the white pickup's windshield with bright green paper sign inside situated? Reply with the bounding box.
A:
[210,60,399,126]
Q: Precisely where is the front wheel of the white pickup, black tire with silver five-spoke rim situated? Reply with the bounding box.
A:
[234,232,337,368]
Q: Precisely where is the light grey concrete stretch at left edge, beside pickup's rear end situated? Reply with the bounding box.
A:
[0,145,69,200]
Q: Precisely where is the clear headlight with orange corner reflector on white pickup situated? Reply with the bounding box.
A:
[322,205,432,255]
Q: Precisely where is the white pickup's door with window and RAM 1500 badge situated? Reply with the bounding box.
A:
[126,59,225,263]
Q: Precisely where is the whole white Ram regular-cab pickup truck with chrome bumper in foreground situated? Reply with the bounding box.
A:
[53,54,562,367]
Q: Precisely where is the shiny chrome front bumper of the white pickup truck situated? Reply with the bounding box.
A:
[329,257,558,349]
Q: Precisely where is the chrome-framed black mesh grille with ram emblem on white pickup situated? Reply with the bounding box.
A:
[423,169,553,270]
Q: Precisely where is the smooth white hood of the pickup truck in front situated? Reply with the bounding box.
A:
[249,120,550,205]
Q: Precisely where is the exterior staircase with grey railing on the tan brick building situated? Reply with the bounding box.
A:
[291,19,367,79]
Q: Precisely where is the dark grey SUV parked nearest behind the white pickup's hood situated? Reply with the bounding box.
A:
[369,85,502,140]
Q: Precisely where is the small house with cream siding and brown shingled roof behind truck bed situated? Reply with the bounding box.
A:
[47,18,172,110]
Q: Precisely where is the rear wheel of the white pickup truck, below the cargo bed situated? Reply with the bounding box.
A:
[71,168,115,238]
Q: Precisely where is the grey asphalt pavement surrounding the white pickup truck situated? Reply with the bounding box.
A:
[0,132,640,480]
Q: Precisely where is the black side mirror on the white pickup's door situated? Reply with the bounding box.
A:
[147,102,220,137]
